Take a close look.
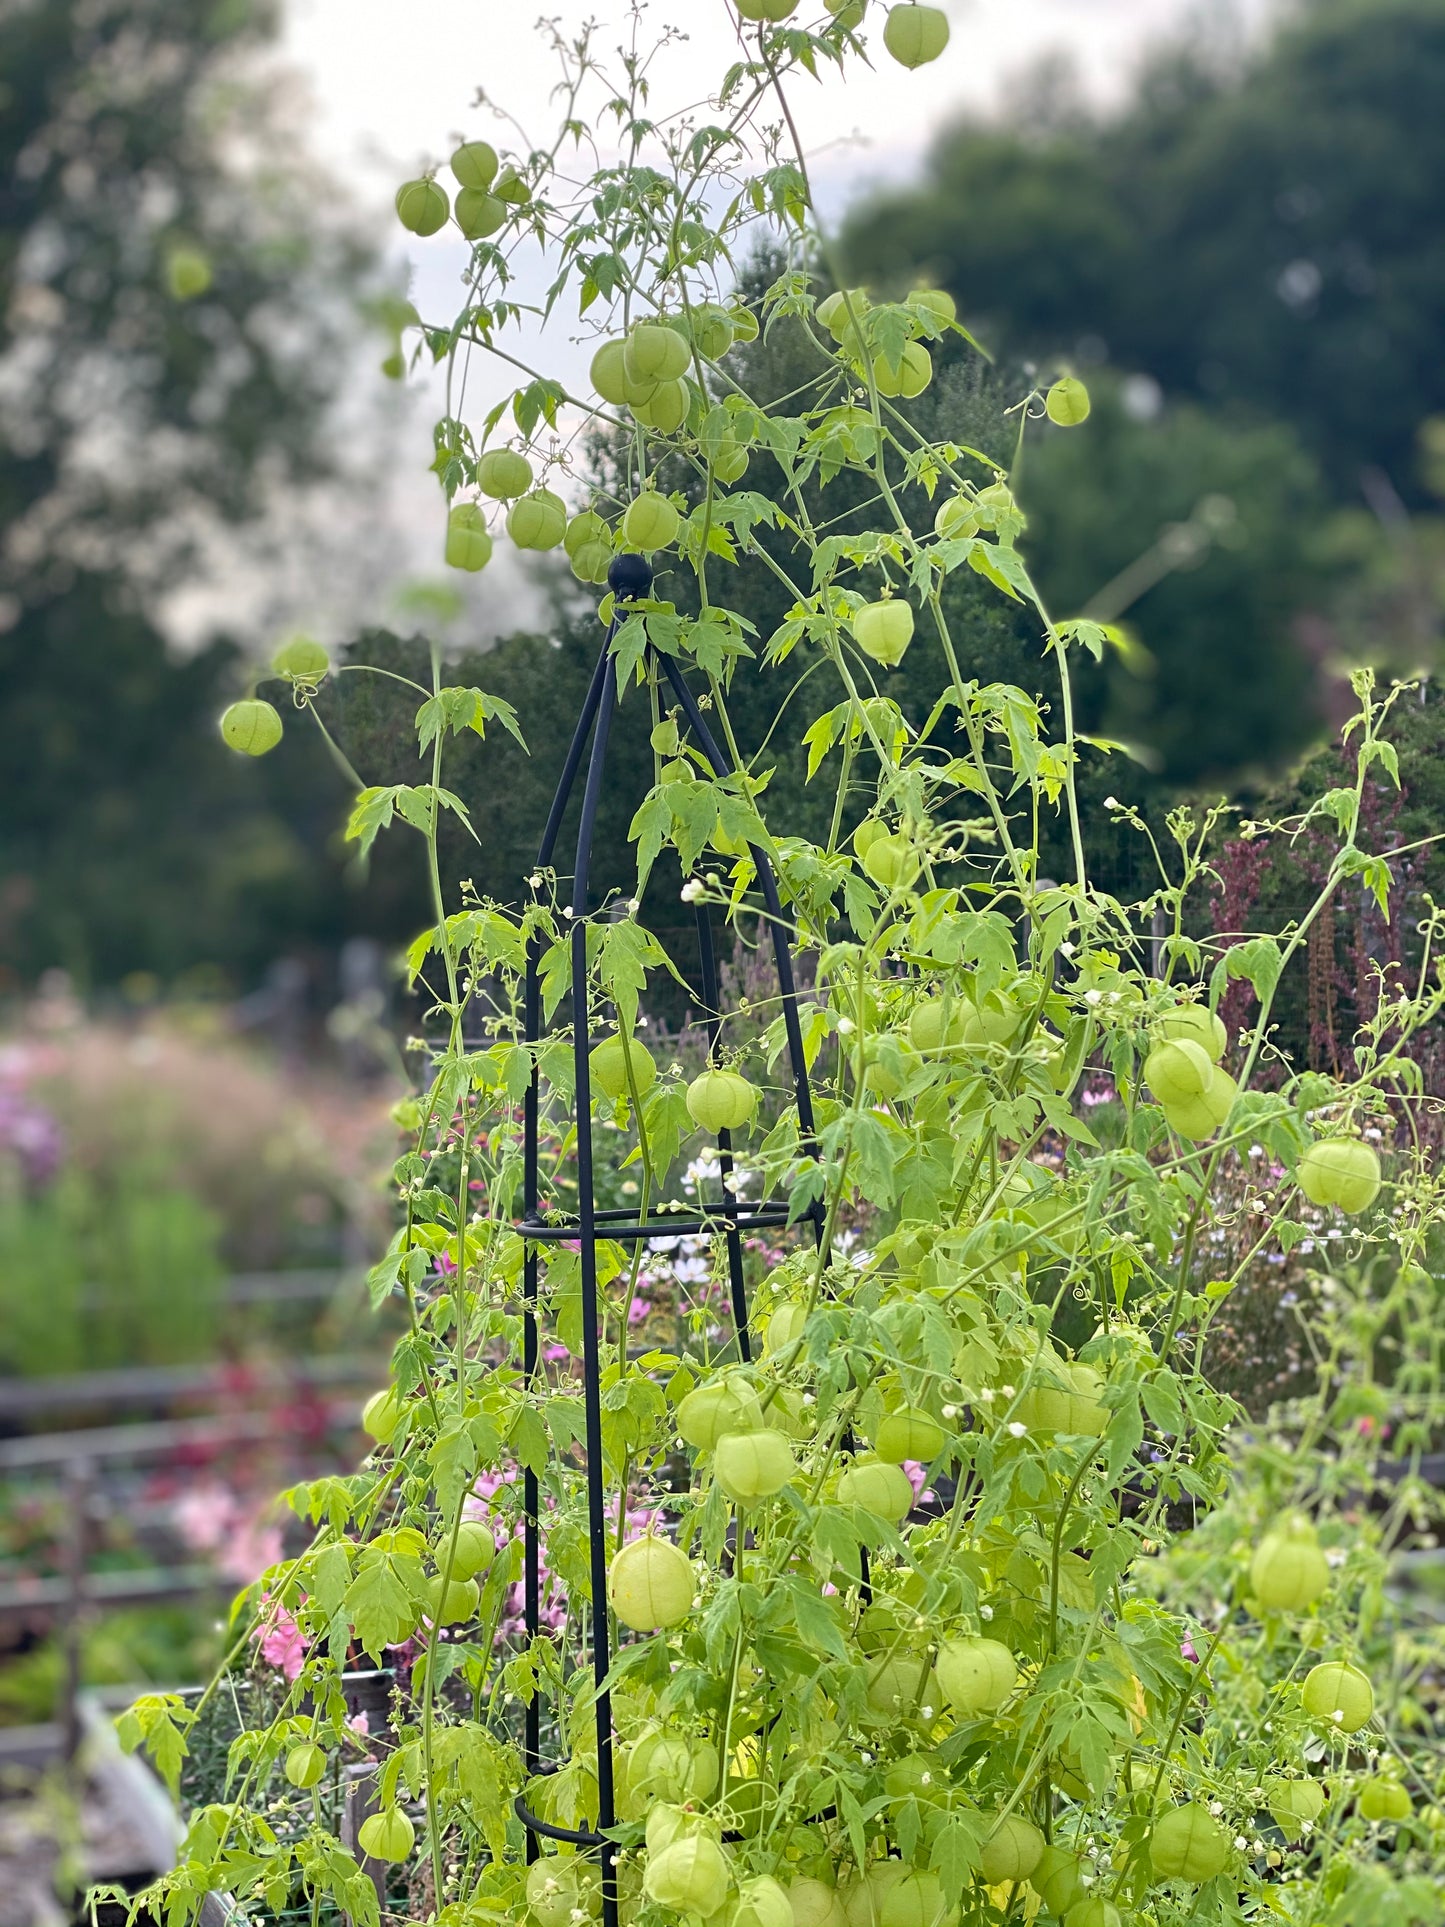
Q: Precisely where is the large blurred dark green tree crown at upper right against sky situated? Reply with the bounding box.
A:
[846,0,1445,499]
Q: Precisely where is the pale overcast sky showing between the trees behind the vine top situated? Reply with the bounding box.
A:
[254,0,1270,647]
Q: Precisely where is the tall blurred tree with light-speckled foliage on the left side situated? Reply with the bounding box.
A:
[0,0,379,983]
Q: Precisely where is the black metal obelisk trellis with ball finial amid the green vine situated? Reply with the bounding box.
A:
[516,555,819,1927]
